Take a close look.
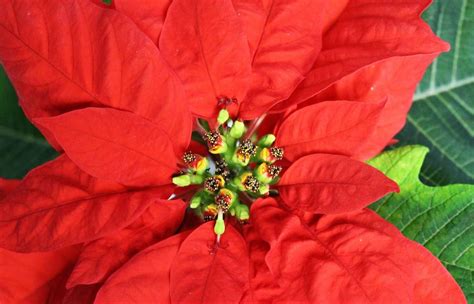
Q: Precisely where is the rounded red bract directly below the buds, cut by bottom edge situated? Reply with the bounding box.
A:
[170,222,249,303]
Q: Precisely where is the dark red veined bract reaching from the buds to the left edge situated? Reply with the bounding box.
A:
[0,156,170,252]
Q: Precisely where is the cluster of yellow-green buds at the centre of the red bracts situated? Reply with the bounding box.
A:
[173,110,284,235]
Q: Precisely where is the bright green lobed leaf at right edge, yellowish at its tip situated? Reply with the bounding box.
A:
[369,146,474,303]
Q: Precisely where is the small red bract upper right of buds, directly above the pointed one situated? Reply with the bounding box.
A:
[276,101,385,161]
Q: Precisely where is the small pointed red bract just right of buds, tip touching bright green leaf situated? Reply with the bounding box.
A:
[277,154,398,213]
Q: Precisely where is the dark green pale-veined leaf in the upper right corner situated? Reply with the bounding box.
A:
[397,0,474,185]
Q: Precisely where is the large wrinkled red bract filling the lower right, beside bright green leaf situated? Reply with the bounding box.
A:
[243,199,465,303]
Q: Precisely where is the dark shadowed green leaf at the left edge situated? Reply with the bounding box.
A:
[0,66,57,178]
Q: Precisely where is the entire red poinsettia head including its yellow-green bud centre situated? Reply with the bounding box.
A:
[0,0,465,303]
